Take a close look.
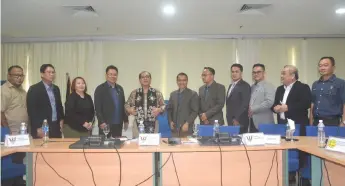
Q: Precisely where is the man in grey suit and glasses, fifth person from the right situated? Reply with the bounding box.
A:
[199,67,225,125]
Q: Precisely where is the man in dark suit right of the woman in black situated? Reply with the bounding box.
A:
[94,65,128,137]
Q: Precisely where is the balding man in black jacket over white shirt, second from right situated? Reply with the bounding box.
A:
[272,65,311,136]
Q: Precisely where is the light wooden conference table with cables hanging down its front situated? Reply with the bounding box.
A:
[1,137,345,186]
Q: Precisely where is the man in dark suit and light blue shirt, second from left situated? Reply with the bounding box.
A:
[26,64,64,138]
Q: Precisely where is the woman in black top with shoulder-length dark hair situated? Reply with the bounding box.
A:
[64,77,95,138]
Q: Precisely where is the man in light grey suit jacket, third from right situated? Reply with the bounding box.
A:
[248,64,275,132]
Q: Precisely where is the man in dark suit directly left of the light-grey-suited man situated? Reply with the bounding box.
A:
[226,64,251,133]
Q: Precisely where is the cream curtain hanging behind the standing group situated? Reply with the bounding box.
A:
[1,39,345,125]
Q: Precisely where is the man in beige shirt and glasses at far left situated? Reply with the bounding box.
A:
[1,65,29,134]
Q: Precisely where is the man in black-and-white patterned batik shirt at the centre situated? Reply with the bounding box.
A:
[125,71,165,137]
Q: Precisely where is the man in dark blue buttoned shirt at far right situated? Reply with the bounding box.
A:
[310,57,345,126]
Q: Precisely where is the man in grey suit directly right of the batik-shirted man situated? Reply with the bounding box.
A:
[168,72,199,137]
